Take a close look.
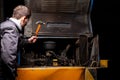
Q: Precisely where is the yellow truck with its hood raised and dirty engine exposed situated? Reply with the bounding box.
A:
[16,0,108,80]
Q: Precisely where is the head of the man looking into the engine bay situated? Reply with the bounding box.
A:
[12,5,31,27]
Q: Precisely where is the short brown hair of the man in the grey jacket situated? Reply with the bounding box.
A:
[12,5,31,19]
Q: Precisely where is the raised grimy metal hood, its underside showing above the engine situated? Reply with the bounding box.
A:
[25,0,92,37]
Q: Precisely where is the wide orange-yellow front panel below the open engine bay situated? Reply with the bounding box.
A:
[16,67,85,80]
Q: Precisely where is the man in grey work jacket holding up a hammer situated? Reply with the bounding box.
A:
[0,5,37,80]
